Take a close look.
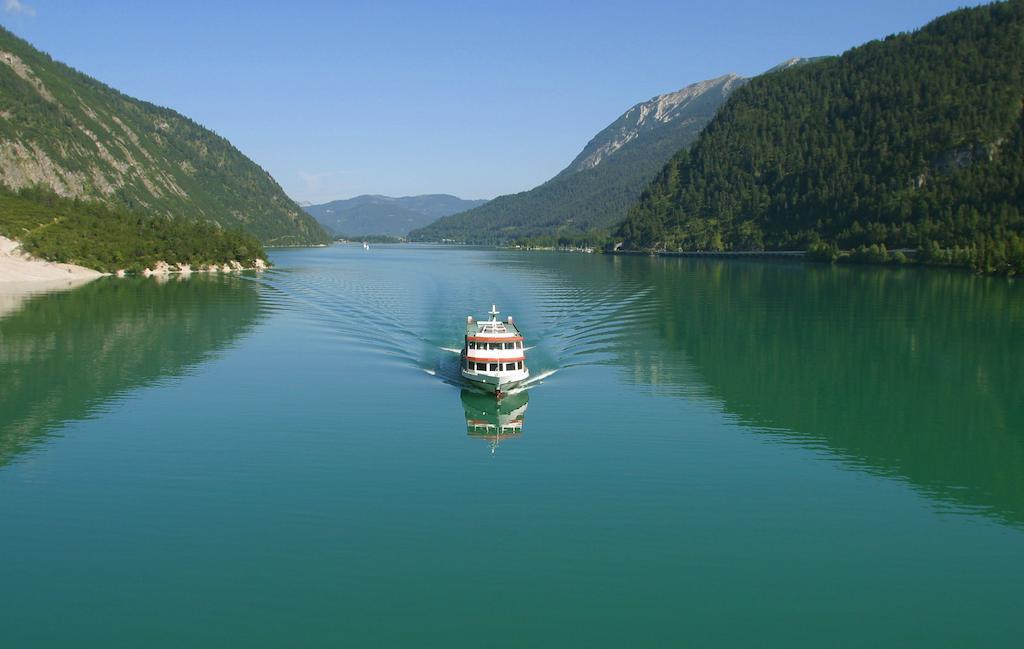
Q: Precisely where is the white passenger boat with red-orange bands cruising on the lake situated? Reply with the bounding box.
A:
[460,304,529,398]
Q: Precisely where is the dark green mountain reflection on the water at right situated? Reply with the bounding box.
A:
[596,253,1024,524]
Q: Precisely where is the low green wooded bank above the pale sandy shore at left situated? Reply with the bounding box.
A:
[0,188,266,272]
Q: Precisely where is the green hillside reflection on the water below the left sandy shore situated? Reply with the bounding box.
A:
[0,275,260,467]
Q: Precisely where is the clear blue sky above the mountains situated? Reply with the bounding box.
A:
[0,0,991,202]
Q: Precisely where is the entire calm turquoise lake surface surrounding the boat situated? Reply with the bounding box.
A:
[0,246,1024,647]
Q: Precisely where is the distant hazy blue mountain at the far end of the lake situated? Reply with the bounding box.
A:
[304,193,486,236]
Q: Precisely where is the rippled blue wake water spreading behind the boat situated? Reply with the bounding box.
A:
[260,246,657,388]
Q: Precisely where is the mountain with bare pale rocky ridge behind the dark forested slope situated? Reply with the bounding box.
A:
[410,70,746,244]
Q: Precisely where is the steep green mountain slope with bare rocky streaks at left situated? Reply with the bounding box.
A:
[0,28,328,245]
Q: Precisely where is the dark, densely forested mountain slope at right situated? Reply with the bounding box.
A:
[616,0,1024,272]
